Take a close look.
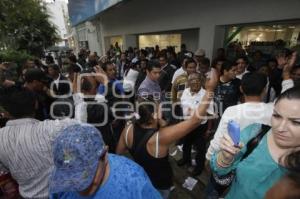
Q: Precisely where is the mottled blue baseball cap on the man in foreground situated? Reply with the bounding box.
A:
[49,124,106,193]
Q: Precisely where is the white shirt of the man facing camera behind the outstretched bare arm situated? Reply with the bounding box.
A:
[180,88,214,124]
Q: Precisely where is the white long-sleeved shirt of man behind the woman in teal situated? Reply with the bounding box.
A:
[206,102,274,160]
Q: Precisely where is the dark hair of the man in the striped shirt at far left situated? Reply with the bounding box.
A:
[0,86,37,119]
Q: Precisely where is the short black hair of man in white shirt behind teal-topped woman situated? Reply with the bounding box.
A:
[241,72,267,96]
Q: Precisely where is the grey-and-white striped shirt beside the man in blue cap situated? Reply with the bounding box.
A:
[0,118,77,198]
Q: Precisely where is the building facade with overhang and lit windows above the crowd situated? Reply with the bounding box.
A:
[69,0,300,57]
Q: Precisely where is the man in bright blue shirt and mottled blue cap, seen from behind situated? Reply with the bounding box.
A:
[50,124,161,199]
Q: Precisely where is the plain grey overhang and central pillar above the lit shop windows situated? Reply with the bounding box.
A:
[92,0,300,57]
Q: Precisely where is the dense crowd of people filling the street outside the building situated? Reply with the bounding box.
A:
[0,43,300,199]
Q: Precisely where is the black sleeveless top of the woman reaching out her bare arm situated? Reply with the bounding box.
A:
[125,125,173,189]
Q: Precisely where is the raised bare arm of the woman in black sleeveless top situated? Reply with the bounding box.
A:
[159,67,218,146]
